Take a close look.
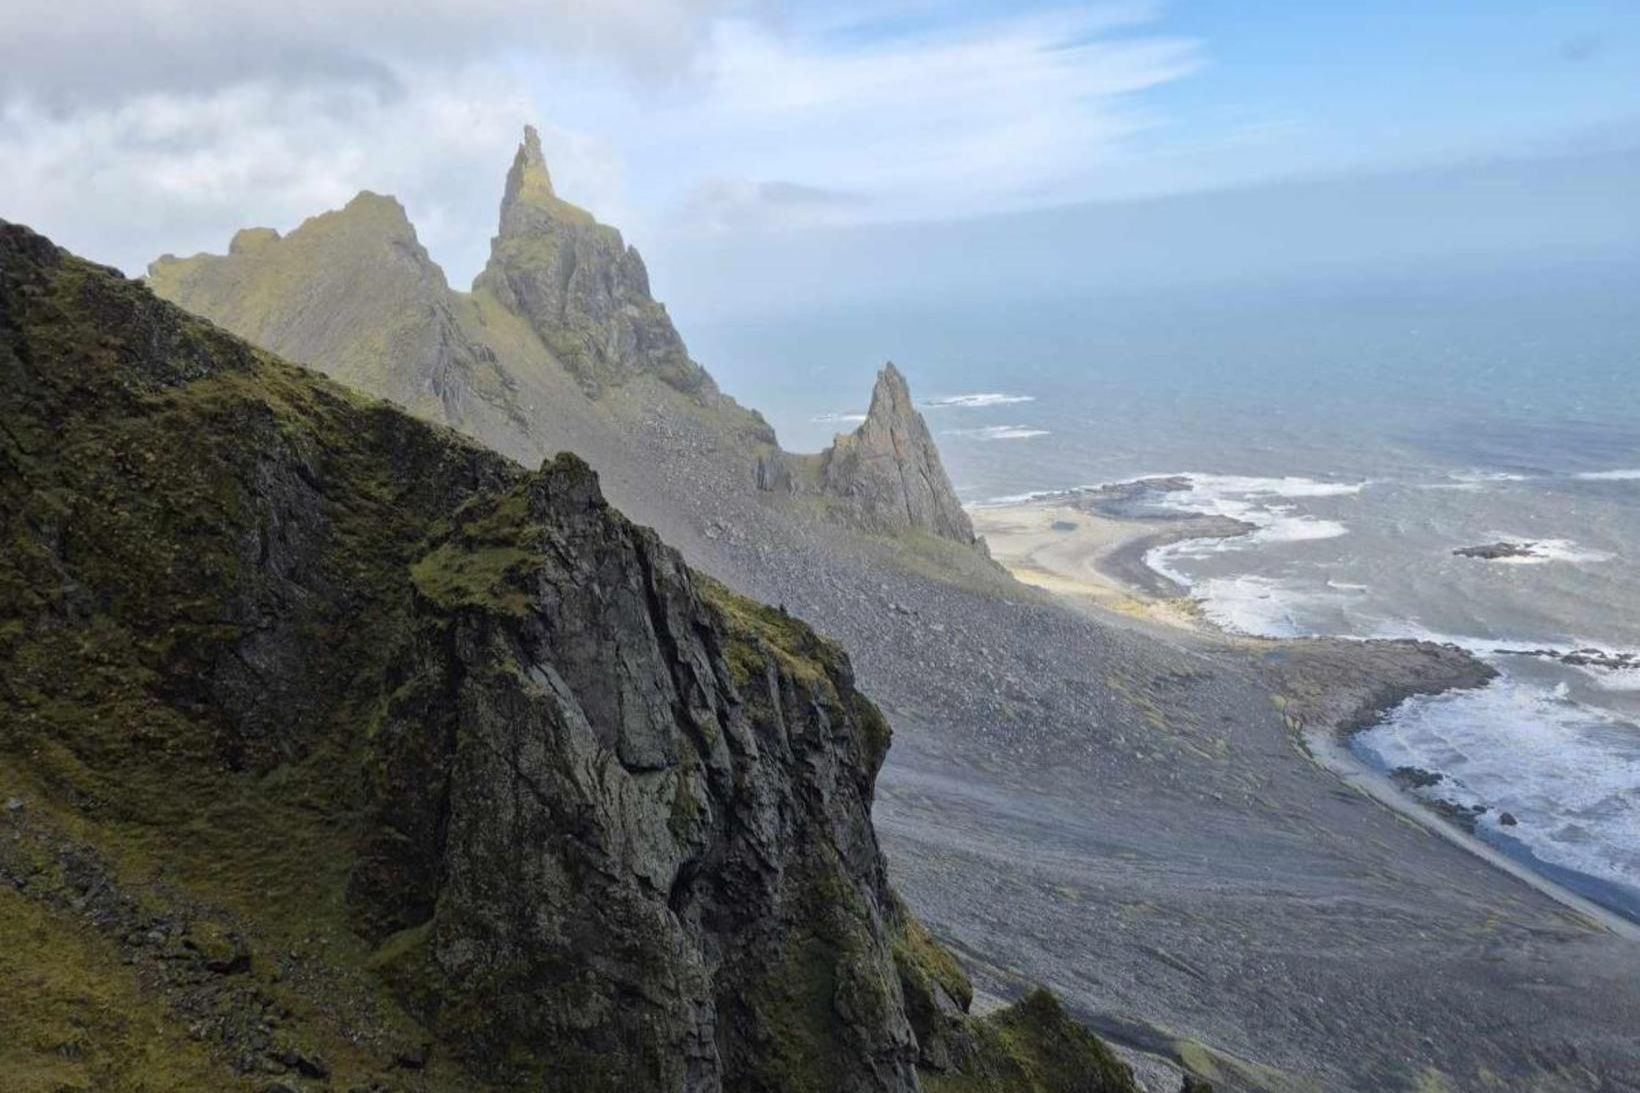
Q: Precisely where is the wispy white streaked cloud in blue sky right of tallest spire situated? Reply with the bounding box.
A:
[654,8,1200,228]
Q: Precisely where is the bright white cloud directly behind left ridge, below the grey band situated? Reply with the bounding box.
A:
[0,66,620,284]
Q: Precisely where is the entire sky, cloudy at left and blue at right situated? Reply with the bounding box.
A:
[0,0,1640,288]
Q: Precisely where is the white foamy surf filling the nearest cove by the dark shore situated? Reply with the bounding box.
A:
[1358,678,1640,888]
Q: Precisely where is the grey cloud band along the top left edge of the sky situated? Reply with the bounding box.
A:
[0,0,723,108]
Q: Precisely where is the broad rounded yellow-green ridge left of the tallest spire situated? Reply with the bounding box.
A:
[148,194,518,425]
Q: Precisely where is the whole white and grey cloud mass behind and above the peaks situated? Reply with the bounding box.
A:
[0,0,1197,286]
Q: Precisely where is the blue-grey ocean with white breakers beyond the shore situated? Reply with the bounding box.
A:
[687,263,1640,919]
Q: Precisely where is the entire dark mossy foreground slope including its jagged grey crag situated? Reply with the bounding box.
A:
[0,216,1130,1091]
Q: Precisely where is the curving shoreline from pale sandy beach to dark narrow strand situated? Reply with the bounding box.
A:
[969,484,1640,940]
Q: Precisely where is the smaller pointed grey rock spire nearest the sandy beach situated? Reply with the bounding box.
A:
[820,363,977,543]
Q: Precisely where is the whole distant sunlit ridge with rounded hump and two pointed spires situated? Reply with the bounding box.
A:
[149,128,974,547]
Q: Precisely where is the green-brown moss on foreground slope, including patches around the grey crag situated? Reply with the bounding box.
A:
[0,223,1154,1093]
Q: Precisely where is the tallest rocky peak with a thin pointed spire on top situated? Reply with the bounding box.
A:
[474,128,717,400]
